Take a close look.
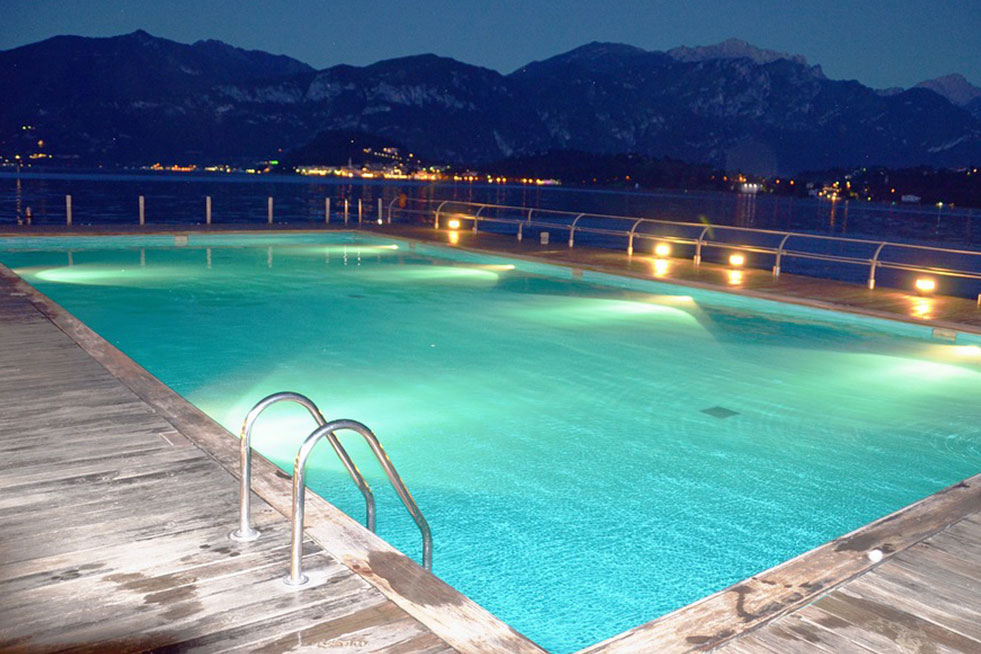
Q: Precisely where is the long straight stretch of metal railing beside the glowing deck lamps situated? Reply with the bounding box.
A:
[414,200,981,288]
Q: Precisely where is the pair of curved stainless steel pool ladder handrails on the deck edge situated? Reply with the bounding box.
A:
[229,392,433,587]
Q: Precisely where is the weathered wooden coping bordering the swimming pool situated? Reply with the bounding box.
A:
[0,232,981,654]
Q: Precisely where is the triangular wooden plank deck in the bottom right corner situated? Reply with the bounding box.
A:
[714,513,981,654]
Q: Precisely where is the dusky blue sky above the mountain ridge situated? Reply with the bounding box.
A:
[0,0,981,88]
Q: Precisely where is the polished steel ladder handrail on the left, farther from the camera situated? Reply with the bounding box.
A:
[228,391,375,543]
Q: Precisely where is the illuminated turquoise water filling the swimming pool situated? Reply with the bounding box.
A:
[0,234,981,652]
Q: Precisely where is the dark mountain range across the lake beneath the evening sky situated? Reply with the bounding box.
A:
[0,31,981,174]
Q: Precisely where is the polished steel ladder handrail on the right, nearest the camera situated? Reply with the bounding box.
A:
[283,420,433,587]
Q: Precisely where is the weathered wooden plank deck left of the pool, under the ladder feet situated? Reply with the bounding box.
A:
[0,279,456,654]
